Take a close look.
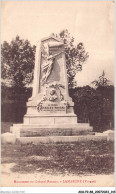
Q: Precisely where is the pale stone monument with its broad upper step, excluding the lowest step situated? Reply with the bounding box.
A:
[11,35,92,142]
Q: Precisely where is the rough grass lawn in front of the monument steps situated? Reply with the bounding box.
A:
[1,141,114,175]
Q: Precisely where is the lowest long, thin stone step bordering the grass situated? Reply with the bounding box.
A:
[17,135,107,144]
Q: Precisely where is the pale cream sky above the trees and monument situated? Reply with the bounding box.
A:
[1,1,114,86]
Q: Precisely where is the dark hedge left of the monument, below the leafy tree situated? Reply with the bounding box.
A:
[1,86,32,123]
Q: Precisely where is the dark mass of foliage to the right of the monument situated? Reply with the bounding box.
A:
[69,85,114,132]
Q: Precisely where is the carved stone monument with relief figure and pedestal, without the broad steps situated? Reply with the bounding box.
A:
[24,36,77,125]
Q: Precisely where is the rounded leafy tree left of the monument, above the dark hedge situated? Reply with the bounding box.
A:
[1,36,35,88]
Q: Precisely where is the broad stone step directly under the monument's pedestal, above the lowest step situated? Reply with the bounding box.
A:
[10,123,94,137]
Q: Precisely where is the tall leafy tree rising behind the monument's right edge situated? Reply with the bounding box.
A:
[59,30,89,88]
